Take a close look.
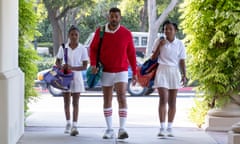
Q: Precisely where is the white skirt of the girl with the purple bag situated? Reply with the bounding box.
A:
[63,71,85,93]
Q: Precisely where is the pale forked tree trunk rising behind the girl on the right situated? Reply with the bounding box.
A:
[147,0,178,56]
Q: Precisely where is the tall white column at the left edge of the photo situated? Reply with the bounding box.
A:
[0,0,24,144]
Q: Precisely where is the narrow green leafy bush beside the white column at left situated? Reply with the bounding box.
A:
[19,0,39,114]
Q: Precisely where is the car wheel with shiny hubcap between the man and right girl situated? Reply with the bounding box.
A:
[127,79,147,96]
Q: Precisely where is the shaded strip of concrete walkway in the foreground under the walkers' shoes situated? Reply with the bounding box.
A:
[17,127,223,144]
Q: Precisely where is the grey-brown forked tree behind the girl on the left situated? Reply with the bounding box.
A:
[43,0,94,55]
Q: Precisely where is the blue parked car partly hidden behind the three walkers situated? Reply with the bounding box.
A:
[35,58,147,96]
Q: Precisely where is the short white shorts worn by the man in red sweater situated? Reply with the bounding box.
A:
[101,71,128,86]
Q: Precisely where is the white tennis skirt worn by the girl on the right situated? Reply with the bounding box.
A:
[153,65,181,89]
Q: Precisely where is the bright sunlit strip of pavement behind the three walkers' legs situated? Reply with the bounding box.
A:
[26,92,195,127]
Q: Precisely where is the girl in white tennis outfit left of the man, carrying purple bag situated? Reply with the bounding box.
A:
[56,26,89,136]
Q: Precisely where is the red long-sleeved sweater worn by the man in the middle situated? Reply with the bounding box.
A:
[90,26,136,75]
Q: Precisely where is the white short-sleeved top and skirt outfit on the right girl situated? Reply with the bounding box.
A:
[153,38,186,89]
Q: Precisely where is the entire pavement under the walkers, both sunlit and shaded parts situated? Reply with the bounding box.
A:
[18,92,227,144]
